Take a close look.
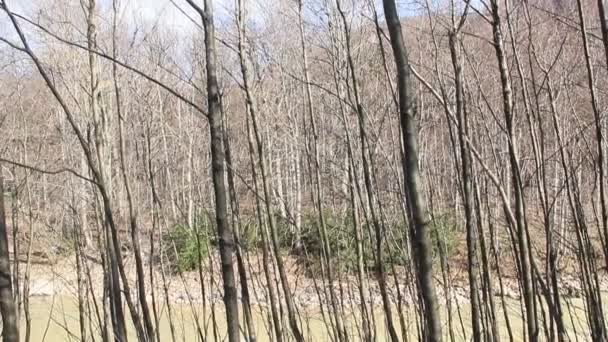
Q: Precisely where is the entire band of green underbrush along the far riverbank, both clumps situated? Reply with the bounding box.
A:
[162,210,458,275]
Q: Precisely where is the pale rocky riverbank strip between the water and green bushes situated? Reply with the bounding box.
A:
[19,248,608,309]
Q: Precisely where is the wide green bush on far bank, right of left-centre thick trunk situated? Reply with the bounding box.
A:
[235,210,440,274]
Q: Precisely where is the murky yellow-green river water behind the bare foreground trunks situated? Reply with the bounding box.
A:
[21,296,600,342]
